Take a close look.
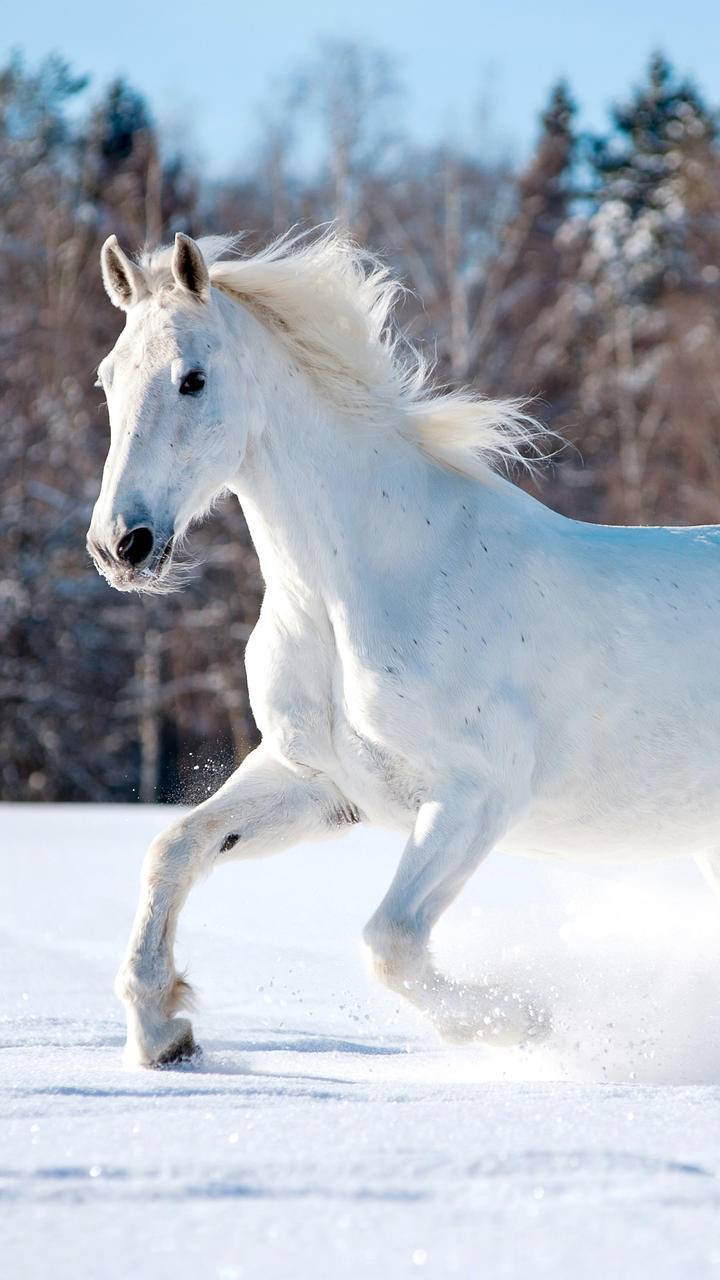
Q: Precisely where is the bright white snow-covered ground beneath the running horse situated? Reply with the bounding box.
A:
[0,806,720,1280]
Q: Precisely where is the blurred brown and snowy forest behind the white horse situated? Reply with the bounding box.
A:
[0,45,720,801]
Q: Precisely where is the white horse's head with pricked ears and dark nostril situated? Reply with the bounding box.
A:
[87,234,250,591]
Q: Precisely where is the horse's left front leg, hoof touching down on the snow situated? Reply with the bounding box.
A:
[115,748,357,1066]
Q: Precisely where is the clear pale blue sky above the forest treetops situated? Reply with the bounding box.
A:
[3,0,720,174]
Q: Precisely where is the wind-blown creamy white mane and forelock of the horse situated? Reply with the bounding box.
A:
[141,230,550,480]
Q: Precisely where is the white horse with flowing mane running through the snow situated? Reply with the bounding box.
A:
[88,225,720,1065]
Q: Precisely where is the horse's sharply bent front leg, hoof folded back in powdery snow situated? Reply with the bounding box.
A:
[364,787,542,1044]
